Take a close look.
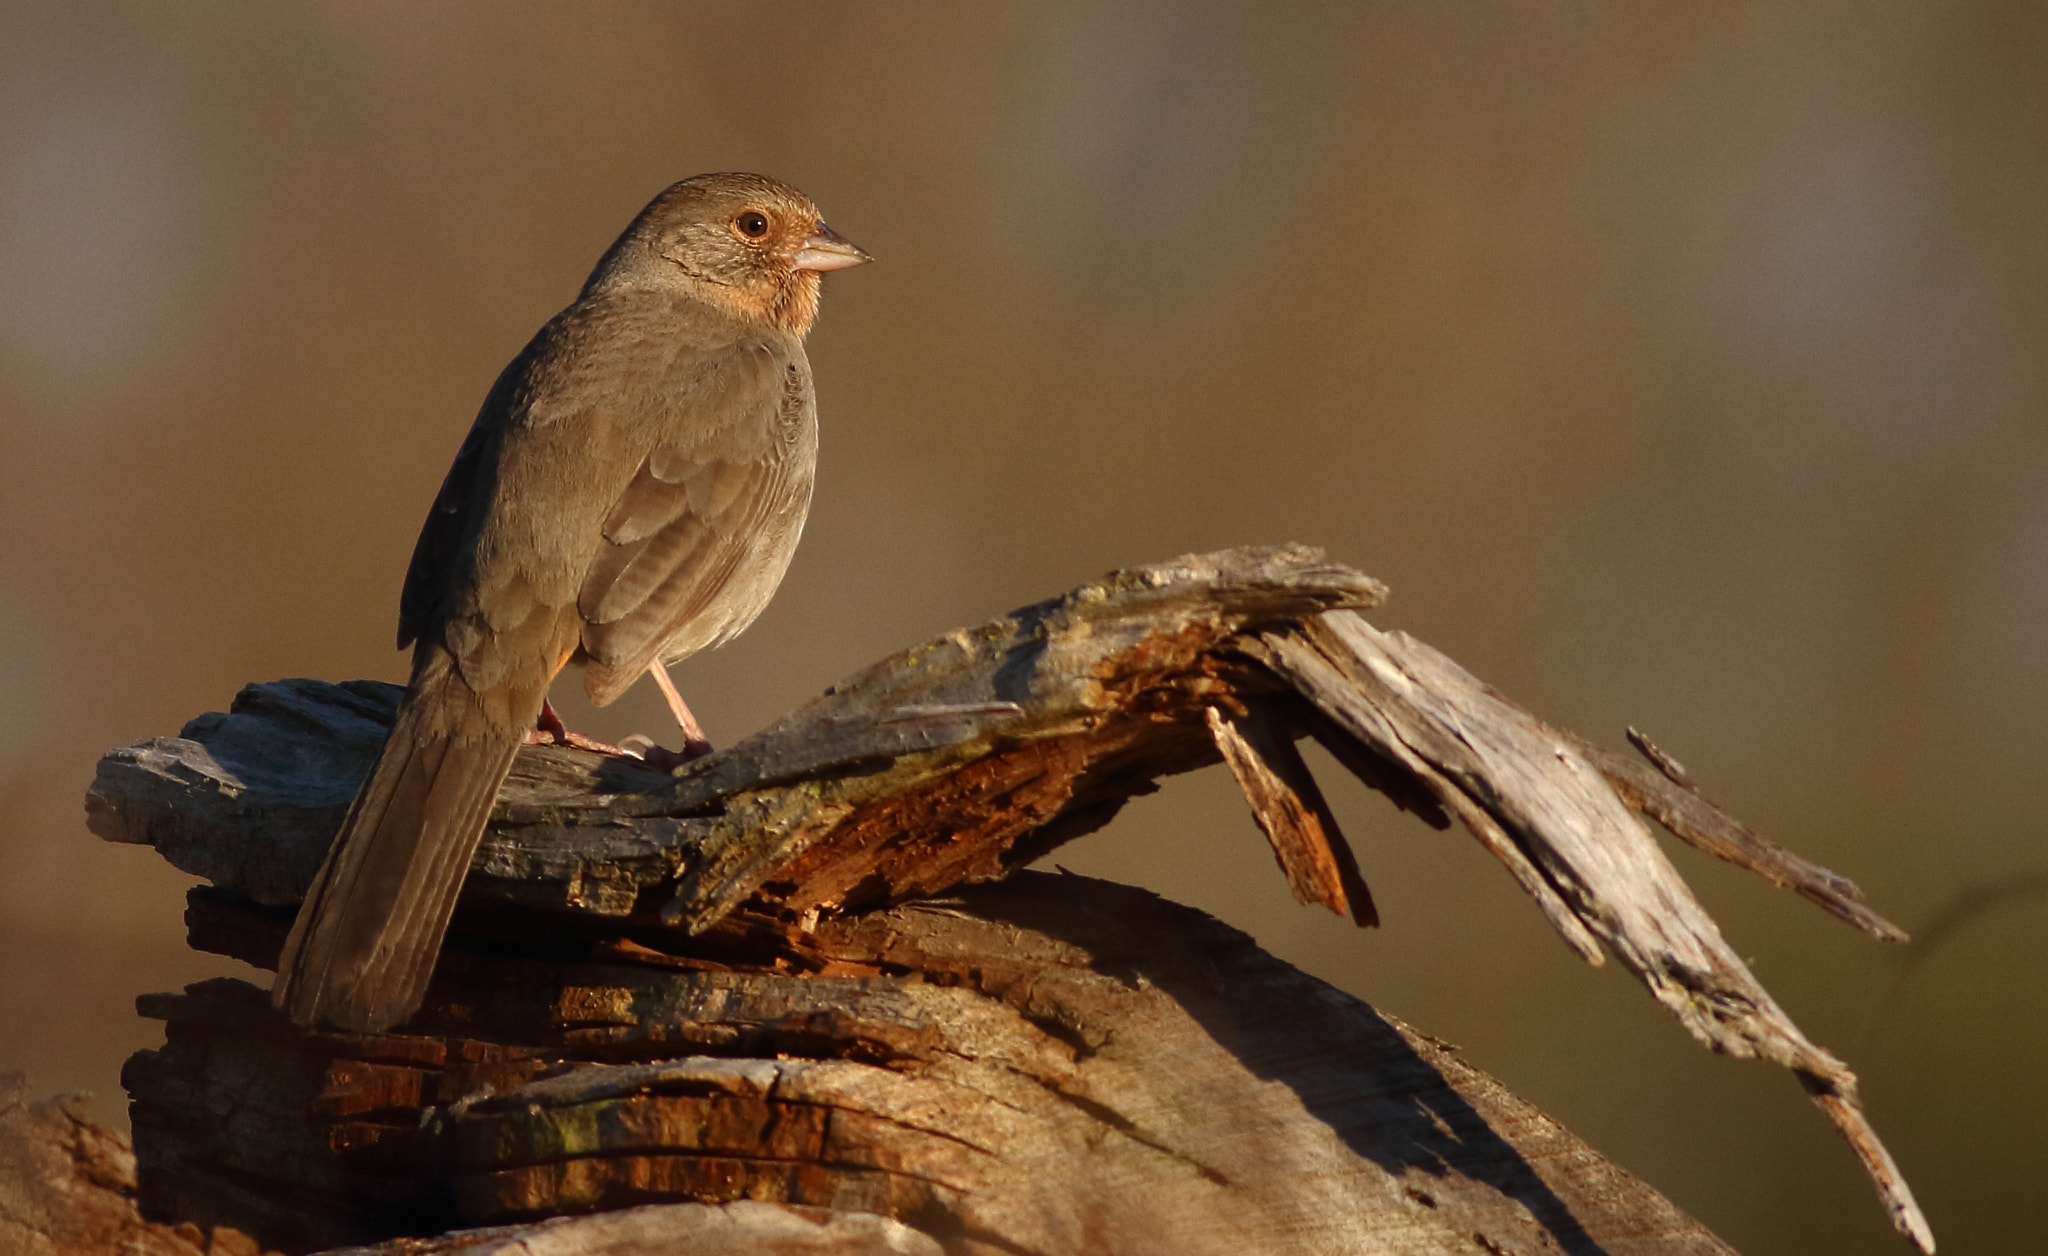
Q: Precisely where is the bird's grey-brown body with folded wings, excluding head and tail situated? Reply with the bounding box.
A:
[387,290,817,705]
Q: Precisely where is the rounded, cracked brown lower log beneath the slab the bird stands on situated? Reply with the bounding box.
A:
[125,873,1729,1256]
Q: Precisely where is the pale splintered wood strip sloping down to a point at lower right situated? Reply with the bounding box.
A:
[1253,611,1933,1252]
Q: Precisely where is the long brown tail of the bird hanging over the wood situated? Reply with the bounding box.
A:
[270,652,545,1033]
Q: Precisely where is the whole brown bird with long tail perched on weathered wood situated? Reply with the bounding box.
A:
[270,174,868,1033]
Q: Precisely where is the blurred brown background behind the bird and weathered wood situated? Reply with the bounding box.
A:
[0,0,2048,1256]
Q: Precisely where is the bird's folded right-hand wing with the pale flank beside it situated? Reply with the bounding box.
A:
[575,338,817,705]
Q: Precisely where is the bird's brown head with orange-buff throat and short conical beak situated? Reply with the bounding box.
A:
[584,174,872,336]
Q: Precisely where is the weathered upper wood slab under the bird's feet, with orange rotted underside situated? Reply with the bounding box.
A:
[86,549,1382,928]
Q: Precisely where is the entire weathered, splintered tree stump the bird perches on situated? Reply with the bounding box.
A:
[88,547,1931,1256]
